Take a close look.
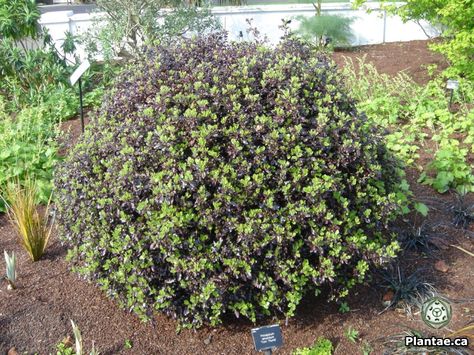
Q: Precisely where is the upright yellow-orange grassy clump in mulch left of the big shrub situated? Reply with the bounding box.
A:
[4,179,52,261]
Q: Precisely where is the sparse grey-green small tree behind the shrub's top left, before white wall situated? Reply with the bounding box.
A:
[84,0,220,58]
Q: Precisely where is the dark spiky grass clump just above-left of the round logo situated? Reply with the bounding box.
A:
[379,264,437,315]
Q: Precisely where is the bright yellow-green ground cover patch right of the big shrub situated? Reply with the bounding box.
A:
[342,59,474,194]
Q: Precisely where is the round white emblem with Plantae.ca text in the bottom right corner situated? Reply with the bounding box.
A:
[405,297,469,349]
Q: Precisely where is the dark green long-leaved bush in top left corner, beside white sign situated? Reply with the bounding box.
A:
[0,0,77,112]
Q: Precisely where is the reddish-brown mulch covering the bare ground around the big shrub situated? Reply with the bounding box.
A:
[0,41,474,355]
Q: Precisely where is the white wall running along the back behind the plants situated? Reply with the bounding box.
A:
[40,2,439,59]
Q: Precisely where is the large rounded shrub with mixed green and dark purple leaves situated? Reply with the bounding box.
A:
[55,34,399,326]
